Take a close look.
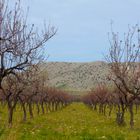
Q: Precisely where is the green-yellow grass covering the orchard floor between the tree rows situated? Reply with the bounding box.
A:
[0,103,140,140]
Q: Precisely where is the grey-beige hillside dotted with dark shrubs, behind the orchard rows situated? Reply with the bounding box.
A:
[46,62,109,91]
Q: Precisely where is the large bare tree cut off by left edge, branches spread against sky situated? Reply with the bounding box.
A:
[0,0,56,87]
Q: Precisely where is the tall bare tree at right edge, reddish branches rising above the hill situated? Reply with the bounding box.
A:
[106,25,140,128]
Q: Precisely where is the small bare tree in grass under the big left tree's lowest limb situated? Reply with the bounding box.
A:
[2,73,27,126]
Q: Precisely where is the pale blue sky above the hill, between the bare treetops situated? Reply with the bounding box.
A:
[22,0,140,62]
